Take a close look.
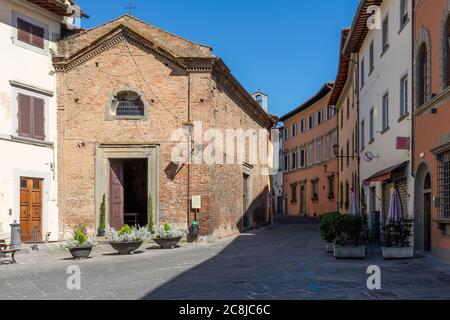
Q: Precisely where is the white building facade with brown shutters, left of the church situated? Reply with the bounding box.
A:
[0,0,79,242]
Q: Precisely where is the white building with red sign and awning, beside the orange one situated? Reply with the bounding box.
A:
[358,0,414,240]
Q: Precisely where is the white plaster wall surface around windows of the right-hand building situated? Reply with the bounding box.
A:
[359,0,414,219]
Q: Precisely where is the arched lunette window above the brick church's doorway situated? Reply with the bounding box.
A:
[111,90,145,118]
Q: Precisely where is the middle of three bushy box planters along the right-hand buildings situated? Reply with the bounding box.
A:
[334,215,366,259]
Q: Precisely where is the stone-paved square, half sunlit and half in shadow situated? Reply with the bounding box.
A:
[0,221,450,300]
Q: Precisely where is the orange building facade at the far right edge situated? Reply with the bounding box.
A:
[413,0,450,259]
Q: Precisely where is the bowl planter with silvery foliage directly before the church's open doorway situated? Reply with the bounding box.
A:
[106,225,152,255]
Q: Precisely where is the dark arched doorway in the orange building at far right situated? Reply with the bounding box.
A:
[414,163,432,251]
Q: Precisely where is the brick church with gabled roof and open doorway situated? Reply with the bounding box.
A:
[53,15,275,239]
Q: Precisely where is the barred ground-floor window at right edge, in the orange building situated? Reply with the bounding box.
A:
[438,151,450,218]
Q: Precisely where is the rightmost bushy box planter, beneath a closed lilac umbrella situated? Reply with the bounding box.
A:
[381,218,414,259]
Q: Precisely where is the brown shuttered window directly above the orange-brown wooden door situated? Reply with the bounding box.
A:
[18,94,45,140]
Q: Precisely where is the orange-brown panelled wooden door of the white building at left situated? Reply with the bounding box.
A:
[20,178,43,242]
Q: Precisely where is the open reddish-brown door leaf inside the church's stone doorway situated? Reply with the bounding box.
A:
[109,160,125,230]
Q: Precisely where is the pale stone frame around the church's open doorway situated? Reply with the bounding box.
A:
[95,144,160,229]
